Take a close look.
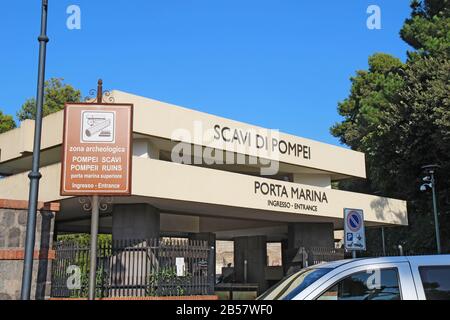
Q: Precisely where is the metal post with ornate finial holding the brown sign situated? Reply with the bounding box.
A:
[89,79,103,300]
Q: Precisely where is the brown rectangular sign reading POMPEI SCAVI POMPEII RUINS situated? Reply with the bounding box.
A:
[61,103,133,196]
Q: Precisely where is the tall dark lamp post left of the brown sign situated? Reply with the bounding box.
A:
[21,0,49,300]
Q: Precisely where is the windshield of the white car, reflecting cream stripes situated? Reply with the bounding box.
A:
[258,268,333,300]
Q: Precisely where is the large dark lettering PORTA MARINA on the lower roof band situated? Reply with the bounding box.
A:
[254,181,328,203]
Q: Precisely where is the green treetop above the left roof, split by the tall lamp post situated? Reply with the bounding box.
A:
[17,78,81,121]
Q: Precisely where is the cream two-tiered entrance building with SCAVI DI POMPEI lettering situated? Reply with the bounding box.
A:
[0,91,408,298]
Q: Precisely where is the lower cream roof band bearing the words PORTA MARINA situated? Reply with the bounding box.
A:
[0,157,408,228]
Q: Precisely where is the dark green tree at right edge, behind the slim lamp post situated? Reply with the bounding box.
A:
[384,55,450,251]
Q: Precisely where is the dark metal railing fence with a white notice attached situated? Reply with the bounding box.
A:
[51,239,214,298]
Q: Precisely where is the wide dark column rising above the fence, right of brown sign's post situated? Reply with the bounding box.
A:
[112,204,160,240]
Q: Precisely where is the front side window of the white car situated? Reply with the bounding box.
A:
[317,268,401,300]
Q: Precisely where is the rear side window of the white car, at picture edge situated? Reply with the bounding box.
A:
[419,266,450,300]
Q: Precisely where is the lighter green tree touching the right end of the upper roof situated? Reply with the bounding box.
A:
[331,53,404,192]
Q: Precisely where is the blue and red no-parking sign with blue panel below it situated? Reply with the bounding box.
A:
[344,209,366,251]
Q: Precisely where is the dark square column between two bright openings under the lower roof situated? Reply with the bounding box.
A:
[234,236,267,292]
